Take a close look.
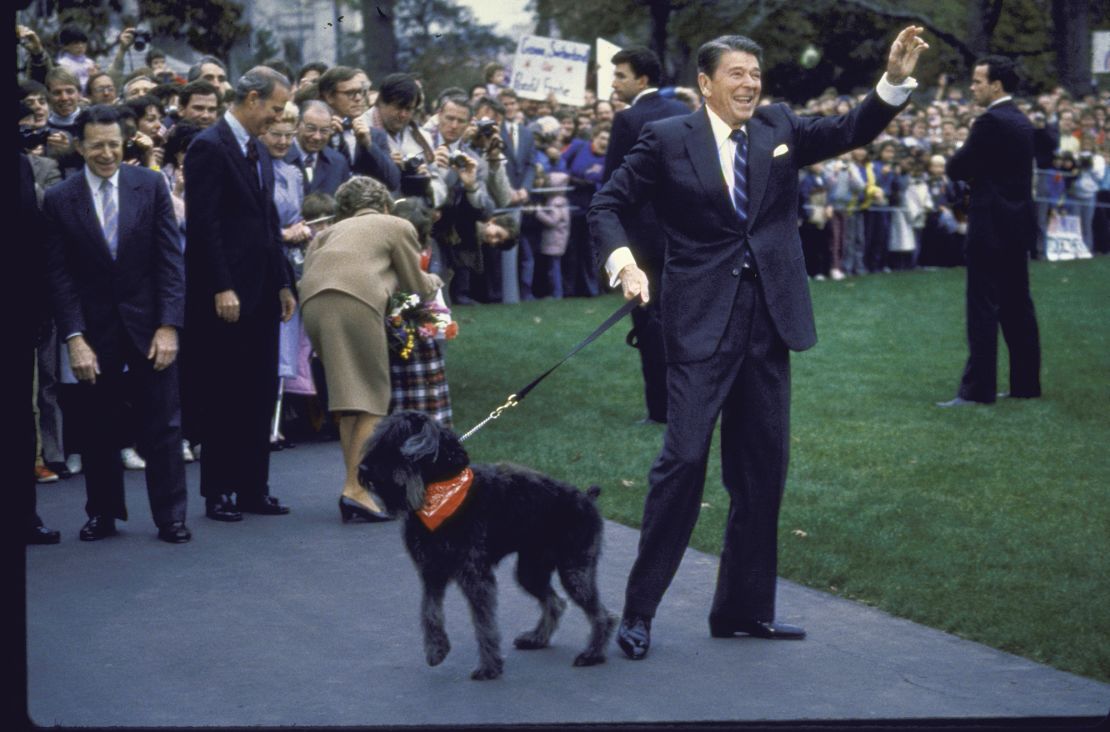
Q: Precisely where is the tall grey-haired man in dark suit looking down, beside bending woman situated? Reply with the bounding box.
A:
[183,67,296,521]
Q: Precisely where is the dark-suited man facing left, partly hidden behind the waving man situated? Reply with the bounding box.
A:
[602,48,690,424]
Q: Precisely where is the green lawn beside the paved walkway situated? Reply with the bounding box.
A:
[437,258,1110,681]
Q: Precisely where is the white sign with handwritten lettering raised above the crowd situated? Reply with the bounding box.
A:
[512,36,589,106]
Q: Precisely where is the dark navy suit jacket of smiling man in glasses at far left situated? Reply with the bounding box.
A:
[43,166,185,362]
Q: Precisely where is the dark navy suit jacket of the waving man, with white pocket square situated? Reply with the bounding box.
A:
[589,91,899,362]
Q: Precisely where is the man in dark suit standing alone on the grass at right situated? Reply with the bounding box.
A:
[937,56,1055,407]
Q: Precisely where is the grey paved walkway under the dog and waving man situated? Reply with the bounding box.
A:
[19,442,1110,726]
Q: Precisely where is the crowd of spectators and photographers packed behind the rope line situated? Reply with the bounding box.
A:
[19,27,1110,497]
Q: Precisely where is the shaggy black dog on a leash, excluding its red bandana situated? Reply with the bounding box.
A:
[359,412,616,679]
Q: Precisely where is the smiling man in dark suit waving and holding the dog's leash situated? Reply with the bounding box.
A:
[589,27,928,659]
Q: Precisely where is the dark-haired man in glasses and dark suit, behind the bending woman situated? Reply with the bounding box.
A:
[312,66,401,192]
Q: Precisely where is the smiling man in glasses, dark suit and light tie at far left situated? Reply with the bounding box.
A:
[43,104,191,543]
